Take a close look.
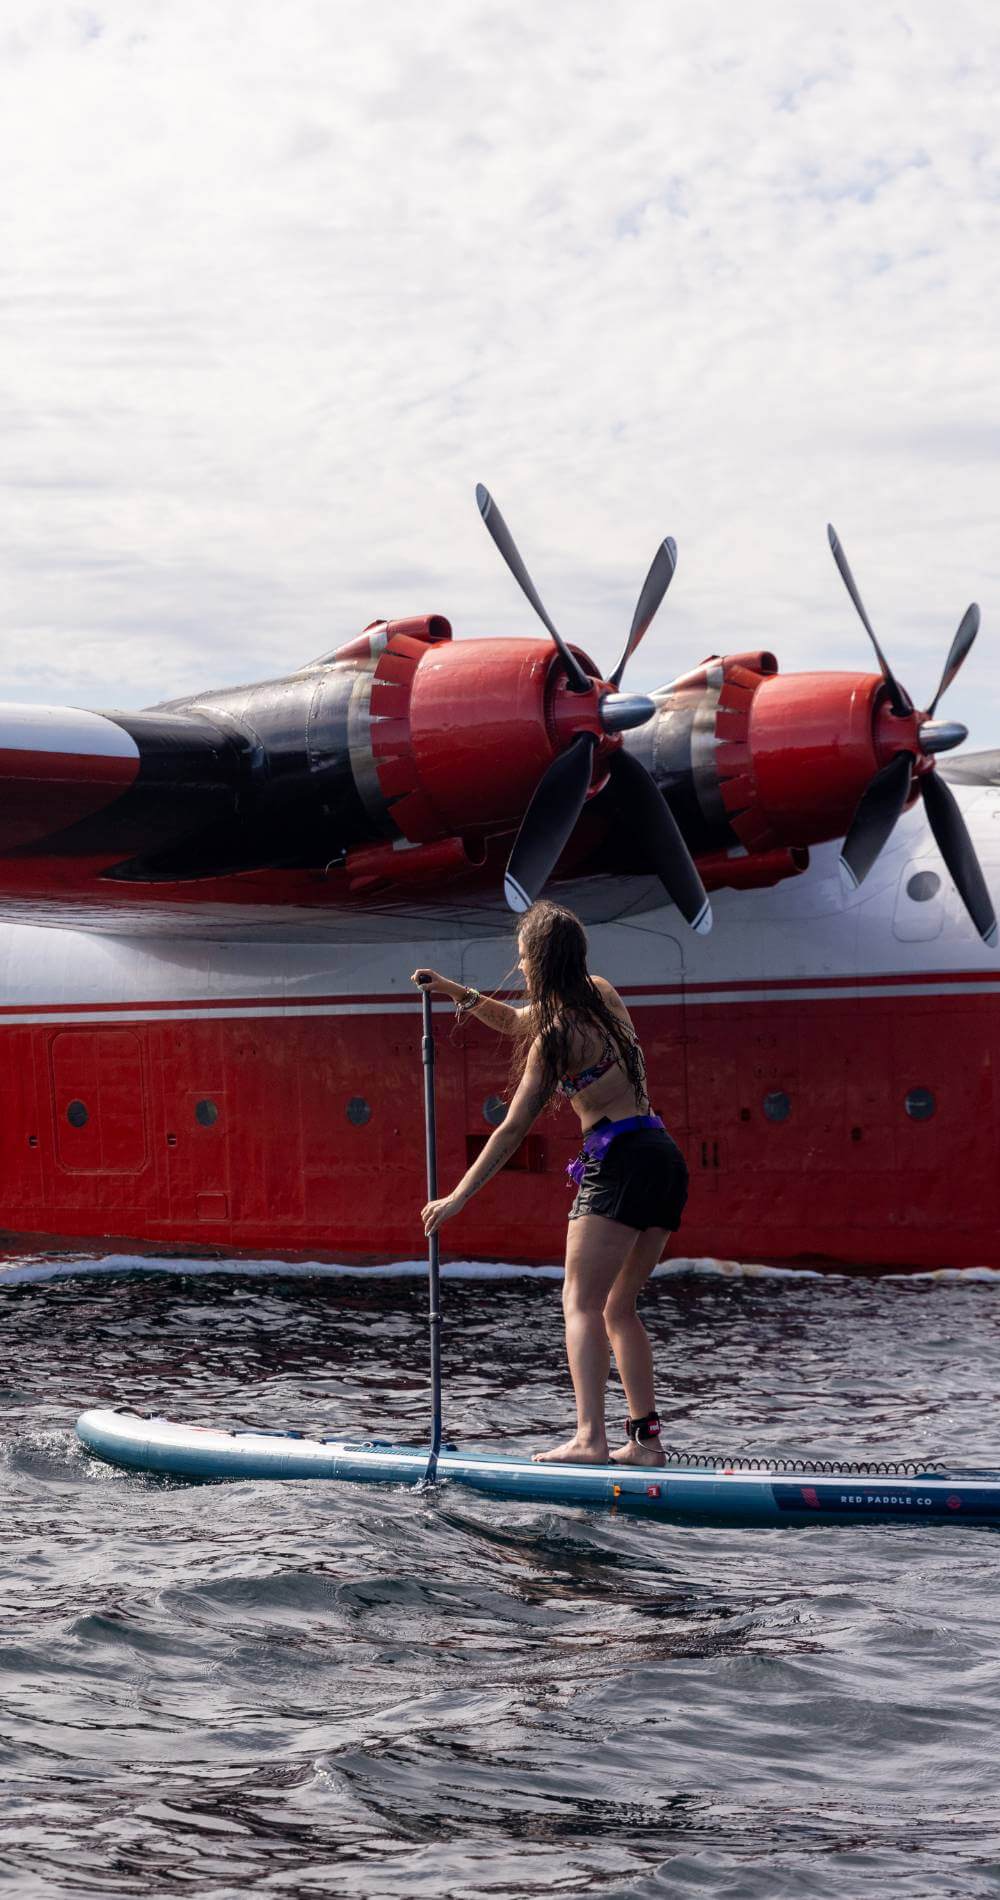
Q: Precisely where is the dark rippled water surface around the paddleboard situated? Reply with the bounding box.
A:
[0,1264,1000,1900]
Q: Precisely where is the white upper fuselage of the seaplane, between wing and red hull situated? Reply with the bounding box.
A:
[0,763,1000,1022]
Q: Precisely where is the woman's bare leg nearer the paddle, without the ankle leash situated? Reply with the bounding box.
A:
[534,1214,639,1465]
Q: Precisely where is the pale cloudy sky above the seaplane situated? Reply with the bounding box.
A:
[0,0,1000,747]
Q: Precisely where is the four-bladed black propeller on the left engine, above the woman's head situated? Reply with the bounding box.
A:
[475,483,711,933]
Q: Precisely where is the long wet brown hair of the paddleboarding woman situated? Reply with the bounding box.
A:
[515,903,646,1102]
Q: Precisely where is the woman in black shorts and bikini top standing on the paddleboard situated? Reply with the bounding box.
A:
[413,903,688,1465]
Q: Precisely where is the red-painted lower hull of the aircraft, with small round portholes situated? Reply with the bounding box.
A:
[0,973,1000,1267]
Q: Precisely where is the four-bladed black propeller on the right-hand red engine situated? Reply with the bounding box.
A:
[827,526,998,950]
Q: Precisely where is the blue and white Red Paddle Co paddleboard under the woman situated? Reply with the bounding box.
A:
[76,1410,1000,1524]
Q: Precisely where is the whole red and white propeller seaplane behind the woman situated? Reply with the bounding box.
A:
[0,490,1000,1267]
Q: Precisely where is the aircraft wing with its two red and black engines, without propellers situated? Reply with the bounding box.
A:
[0,616,930,895]
